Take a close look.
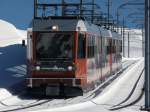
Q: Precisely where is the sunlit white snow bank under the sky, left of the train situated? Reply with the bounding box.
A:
[0,20,27,47]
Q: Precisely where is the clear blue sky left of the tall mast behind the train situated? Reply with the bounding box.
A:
[0,0,33,29]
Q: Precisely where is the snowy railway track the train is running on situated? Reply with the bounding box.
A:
[0,61,137,112]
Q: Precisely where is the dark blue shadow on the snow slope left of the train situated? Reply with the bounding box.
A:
[0,44,26,90]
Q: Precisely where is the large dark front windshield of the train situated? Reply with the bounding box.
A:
[36,32,74,61]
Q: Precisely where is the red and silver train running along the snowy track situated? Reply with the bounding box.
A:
[27,17,122,95]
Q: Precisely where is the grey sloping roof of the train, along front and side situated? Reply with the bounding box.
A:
[33,17,121,39]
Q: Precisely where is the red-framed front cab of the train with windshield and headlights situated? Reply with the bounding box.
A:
[27,16,87,95]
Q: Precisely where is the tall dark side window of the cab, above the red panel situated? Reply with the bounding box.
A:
[78,34,86,58]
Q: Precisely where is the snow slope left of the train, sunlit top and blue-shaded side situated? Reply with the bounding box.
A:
[0,20,26,99]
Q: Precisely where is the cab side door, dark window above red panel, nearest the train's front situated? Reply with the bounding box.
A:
[76,33,87,85]
